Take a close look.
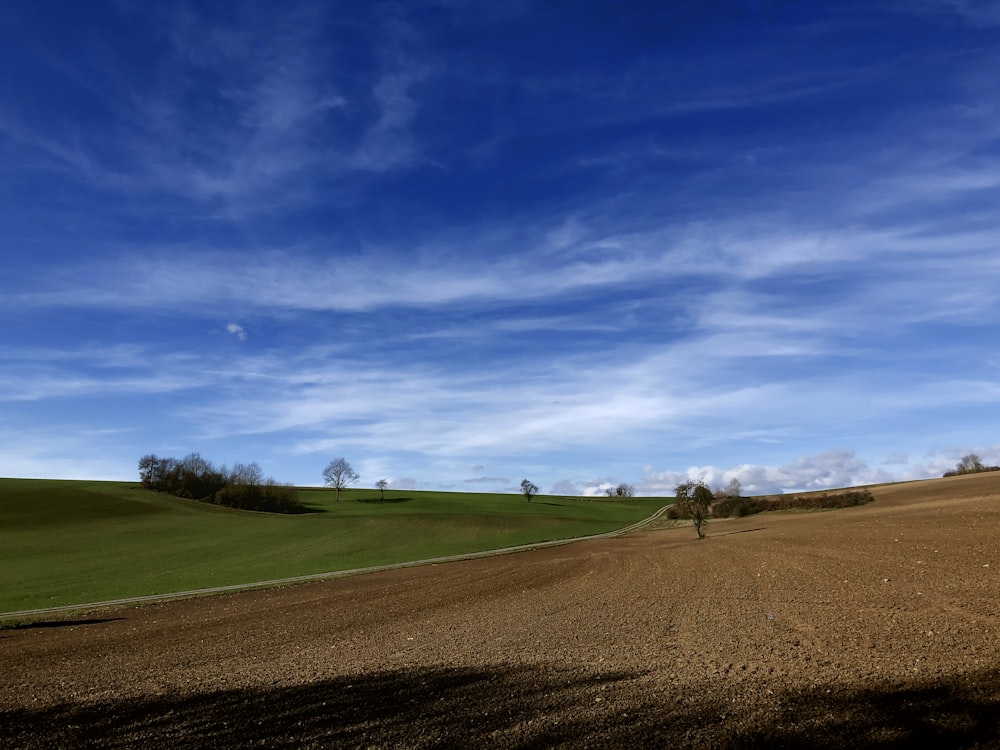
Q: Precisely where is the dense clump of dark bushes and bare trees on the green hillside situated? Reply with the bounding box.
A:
[139,453,307,513]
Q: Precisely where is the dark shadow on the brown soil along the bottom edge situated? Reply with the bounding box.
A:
[0,667,1000,750]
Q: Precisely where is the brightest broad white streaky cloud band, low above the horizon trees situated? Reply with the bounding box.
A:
[133,324,1000,468]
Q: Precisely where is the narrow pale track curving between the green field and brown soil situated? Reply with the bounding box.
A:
[0,504,671,621]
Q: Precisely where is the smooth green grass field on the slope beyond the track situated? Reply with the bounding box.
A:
[0,479,664,612]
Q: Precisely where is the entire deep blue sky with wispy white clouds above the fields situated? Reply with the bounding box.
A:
[0,0,1000,494]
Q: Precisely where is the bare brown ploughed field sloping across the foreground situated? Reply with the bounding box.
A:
[0,473,1000,748]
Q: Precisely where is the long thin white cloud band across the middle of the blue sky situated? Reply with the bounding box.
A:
[7,214,1000,347]
